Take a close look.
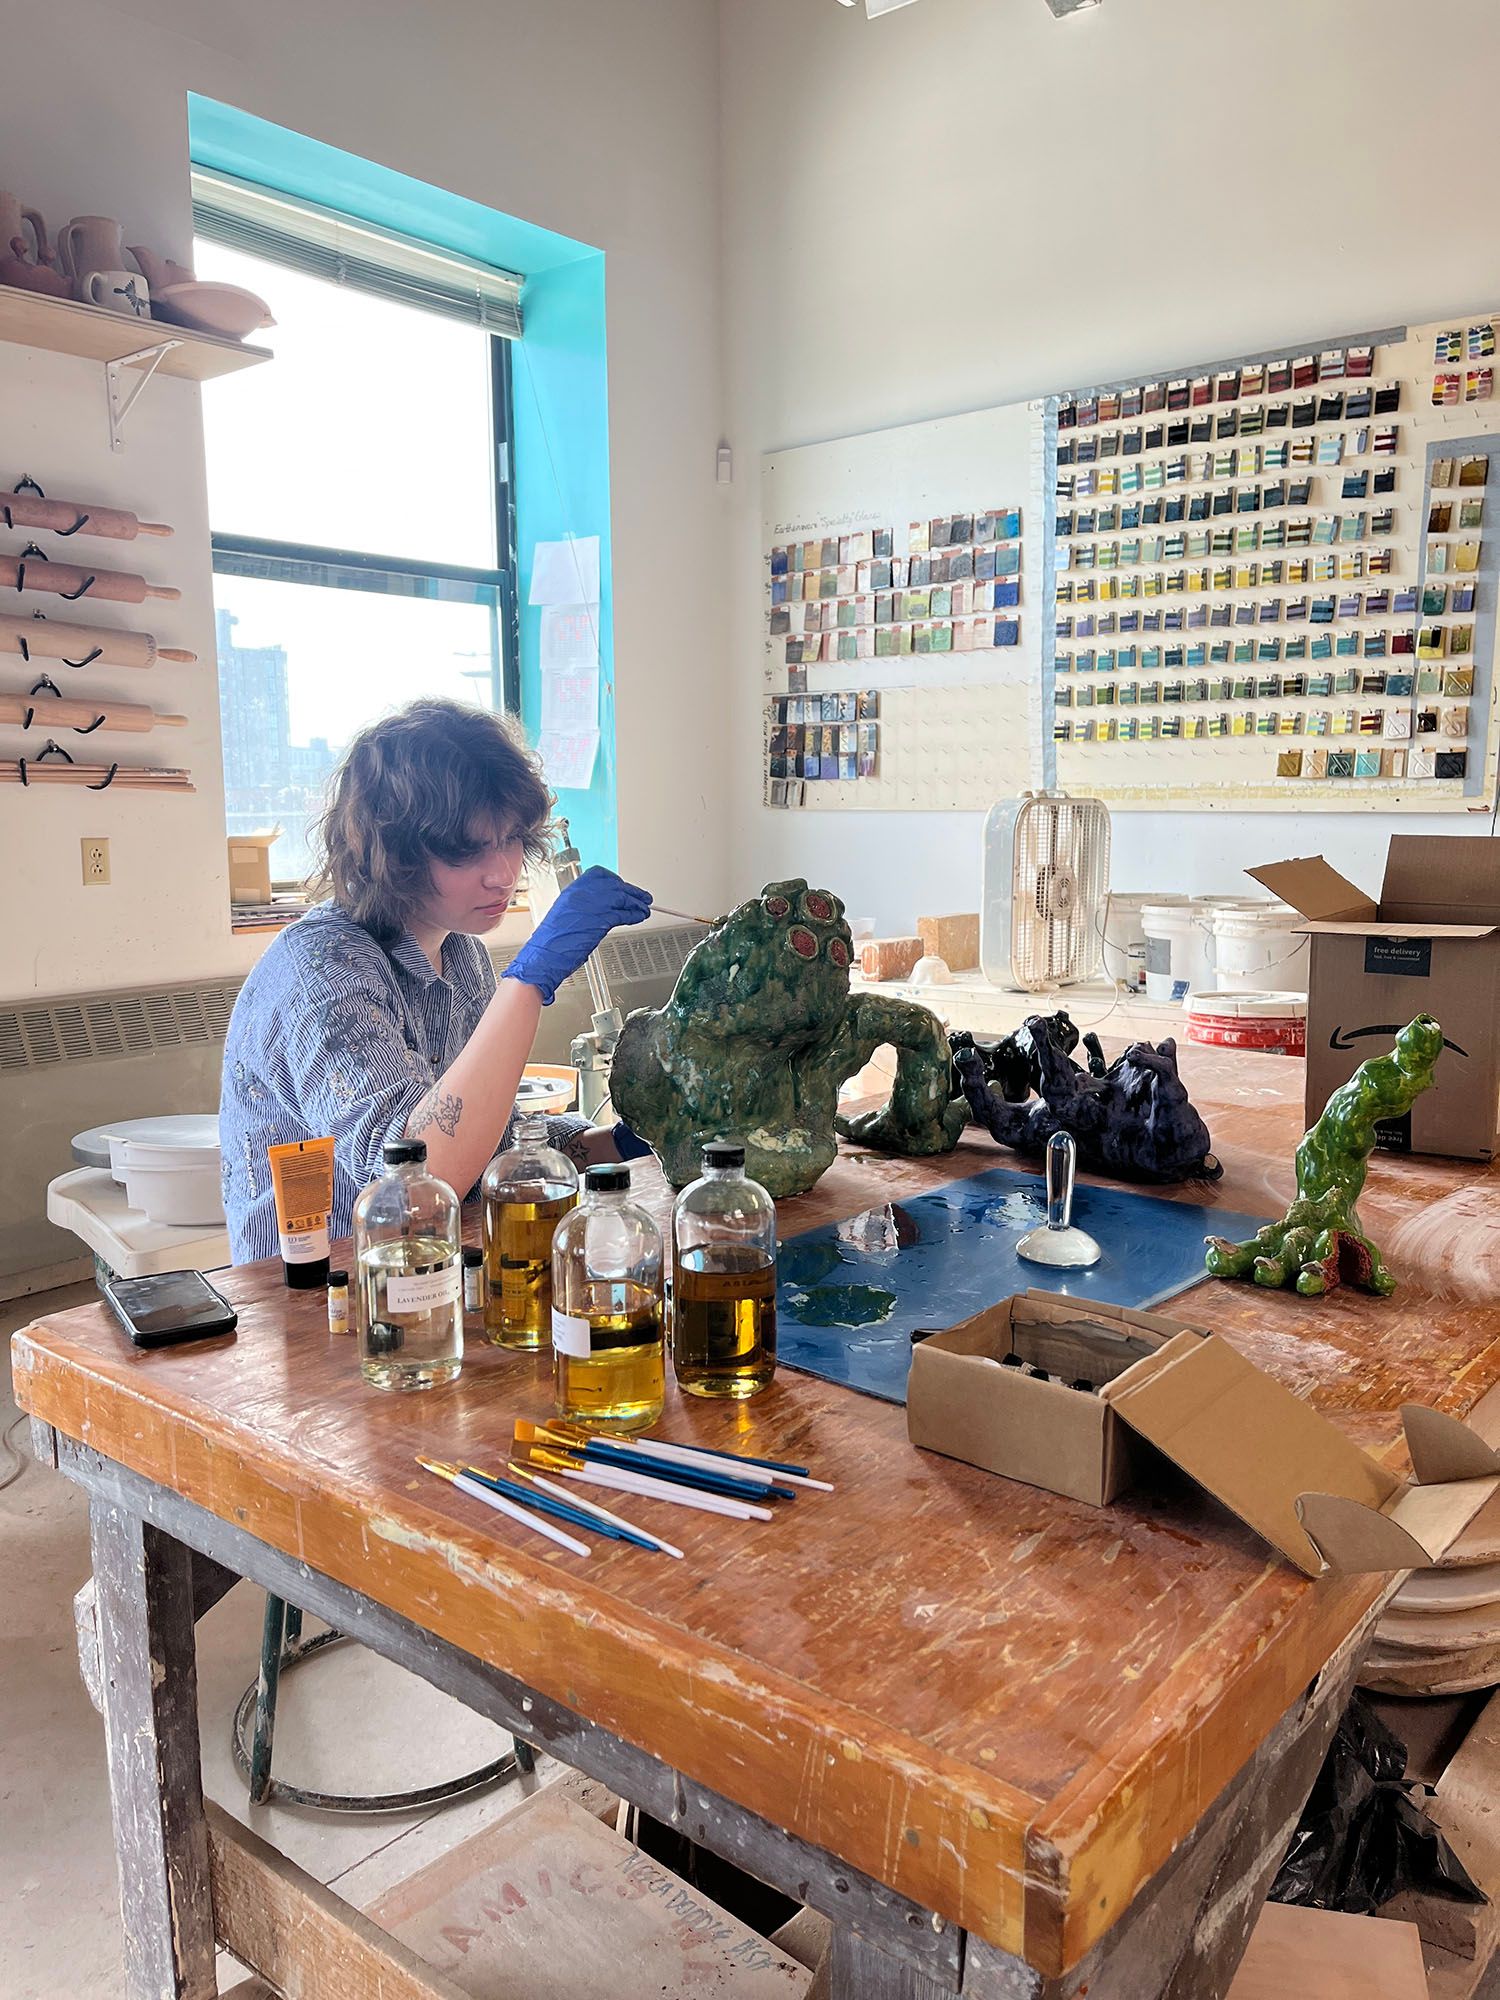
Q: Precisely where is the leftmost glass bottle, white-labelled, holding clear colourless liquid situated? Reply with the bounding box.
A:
[354,1138,464,1388]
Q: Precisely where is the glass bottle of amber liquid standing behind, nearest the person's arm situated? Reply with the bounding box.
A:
[480,1112,578,1348]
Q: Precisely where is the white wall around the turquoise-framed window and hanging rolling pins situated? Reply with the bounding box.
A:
[0,0,728,1000]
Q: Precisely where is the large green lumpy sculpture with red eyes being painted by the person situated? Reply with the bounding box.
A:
[610,880,968,1196]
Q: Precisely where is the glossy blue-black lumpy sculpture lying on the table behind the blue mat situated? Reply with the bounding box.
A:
[952,1014,1224,1182]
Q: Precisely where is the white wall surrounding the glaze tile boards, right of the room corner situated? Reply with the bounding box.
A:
[722,0,1500,928]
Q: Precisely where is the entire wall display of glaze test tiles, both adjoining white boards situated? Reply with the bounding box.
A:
[762,312,1500,812]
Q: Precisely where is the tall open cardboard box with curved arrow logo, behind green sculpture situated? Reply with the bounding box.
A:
[1246,834,1500,1160]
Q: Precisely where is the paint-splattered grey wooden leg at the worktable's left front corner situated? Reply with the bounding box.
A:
[90,1500,218,2000]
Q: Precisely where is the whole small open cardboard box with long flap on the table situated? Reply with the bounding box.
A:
[906,1292,1500,1576]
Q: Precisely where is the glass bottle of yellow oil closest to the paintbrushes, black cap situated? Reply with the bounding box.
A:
[552,1166,666,1432]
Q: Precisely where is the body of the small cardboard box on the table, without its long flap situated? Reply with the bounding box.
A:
[906,1292,1192,1506]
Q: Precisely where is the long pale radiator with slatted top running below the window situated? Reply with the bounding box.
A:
[0,928,702,1298]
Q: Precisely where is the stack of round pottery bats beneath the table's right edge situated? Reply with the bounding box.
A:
[1360,1496,1500,1694]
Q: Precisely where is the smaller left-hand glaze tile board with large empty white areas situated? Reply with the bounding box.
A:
[762,404,1042,810]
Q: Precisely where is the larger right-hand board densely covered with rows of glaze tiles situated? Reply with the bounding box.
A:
[1042,314,1500,812]
